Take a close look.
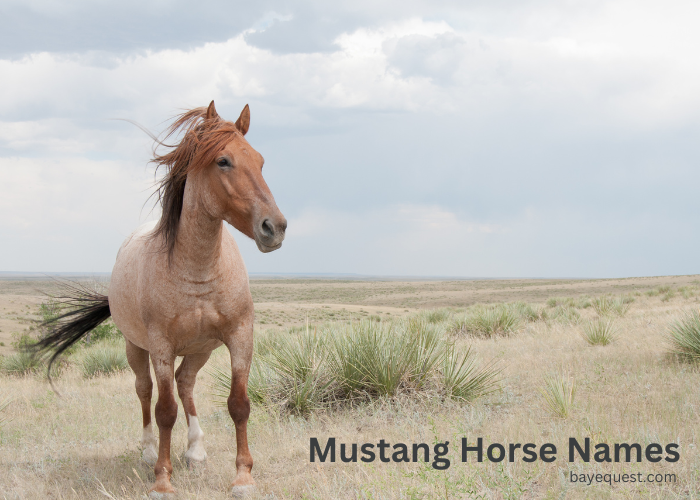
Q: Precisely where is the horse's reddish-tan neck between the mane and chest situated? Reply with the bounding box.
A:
[172,179,223,280]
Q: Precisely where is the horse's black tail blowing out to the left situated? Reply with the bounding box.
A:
[27,282,111,381]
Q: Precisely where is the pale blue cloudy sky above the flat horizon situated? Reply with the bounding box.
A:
[0,0,700,278]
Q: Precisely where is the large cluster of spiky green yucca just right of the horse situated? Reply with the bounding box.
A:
[209,316,499,415]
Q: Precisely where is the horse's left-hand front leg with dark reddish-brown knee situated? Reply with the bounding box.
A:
[148,353,177,499]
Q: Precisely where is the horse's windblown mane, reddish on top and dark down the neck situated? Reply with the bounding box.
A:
[151,108,240,261]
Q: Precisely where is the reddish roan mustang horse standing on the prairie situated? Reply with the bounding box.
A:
[34,101,287,499]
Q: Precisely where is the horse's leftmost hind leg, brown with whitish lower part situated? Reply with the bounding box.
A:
[126,340,158,466]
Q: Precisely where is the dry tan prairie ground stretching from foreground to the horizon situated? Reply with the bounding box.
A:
[0,276,700,500]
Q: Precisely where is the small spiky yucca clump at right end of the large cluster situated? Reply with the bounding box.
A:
[442,344,500,402]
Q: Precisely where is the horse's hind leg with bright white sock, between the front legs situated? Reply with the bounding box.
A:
[175,352,211,468]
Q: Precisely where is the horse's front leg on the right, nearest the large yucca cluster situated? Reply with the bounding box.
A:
[228,328,255,498]
